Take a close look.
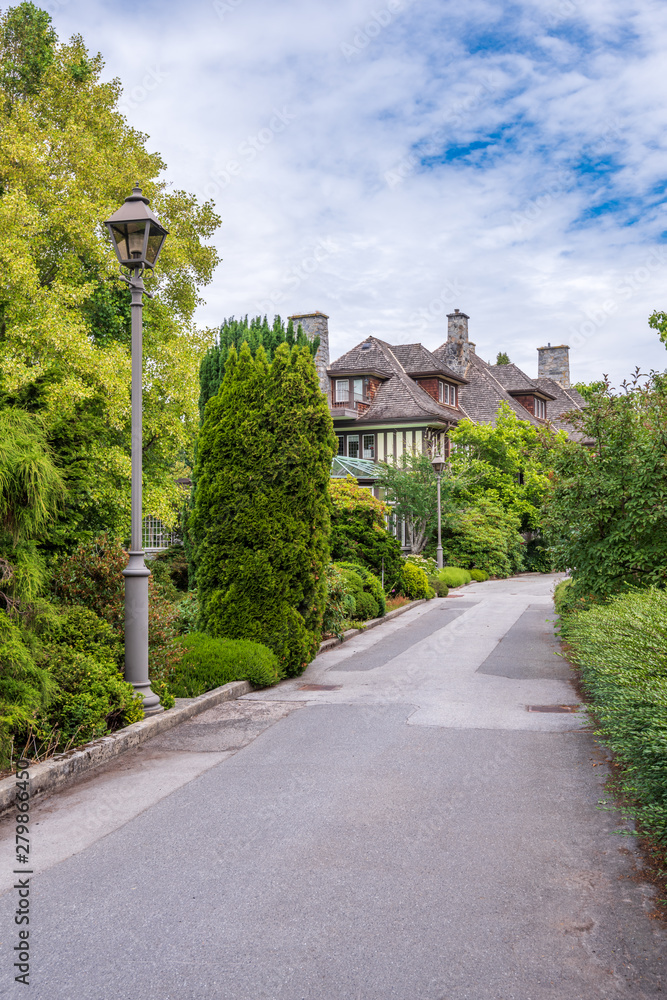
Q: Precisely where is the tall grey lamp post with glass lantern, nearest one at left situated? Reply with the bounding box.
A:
[106,184,169,715]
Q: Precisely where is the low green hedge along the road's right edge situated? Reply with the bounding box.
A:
[559,581,667,850]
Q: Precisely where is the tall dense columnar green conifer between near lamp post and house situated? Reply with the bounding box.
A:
[191,343,336,676]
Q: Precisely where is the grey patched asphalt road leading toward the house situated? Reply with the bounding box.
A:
[0,575,667,1000]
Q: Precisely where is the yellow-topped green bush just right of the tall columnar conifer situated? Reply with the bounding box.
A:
[329,476,403,589]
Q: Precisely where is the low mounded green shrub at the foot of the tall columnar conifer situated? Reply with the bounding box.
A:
[169,632,280,698]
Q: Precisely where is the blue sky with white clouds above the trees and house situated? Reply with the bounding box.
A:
[41,0,667,384]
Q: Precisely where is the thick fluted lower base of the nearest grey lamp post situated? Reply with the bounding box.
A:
[123,551,164,716]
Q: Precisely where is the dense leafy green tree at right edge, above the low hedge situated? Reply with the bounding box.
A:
[545,371,667,599]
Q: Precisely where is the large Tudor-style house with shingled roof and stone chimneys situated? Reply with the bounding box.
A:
[290,309,585,486]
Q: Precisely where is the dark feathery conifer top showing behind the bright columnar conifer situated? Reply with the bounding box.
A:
[199,316,320,420]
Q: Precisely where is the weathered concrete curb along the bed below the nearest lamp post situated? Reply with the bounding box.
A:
[0,681,252,816]
